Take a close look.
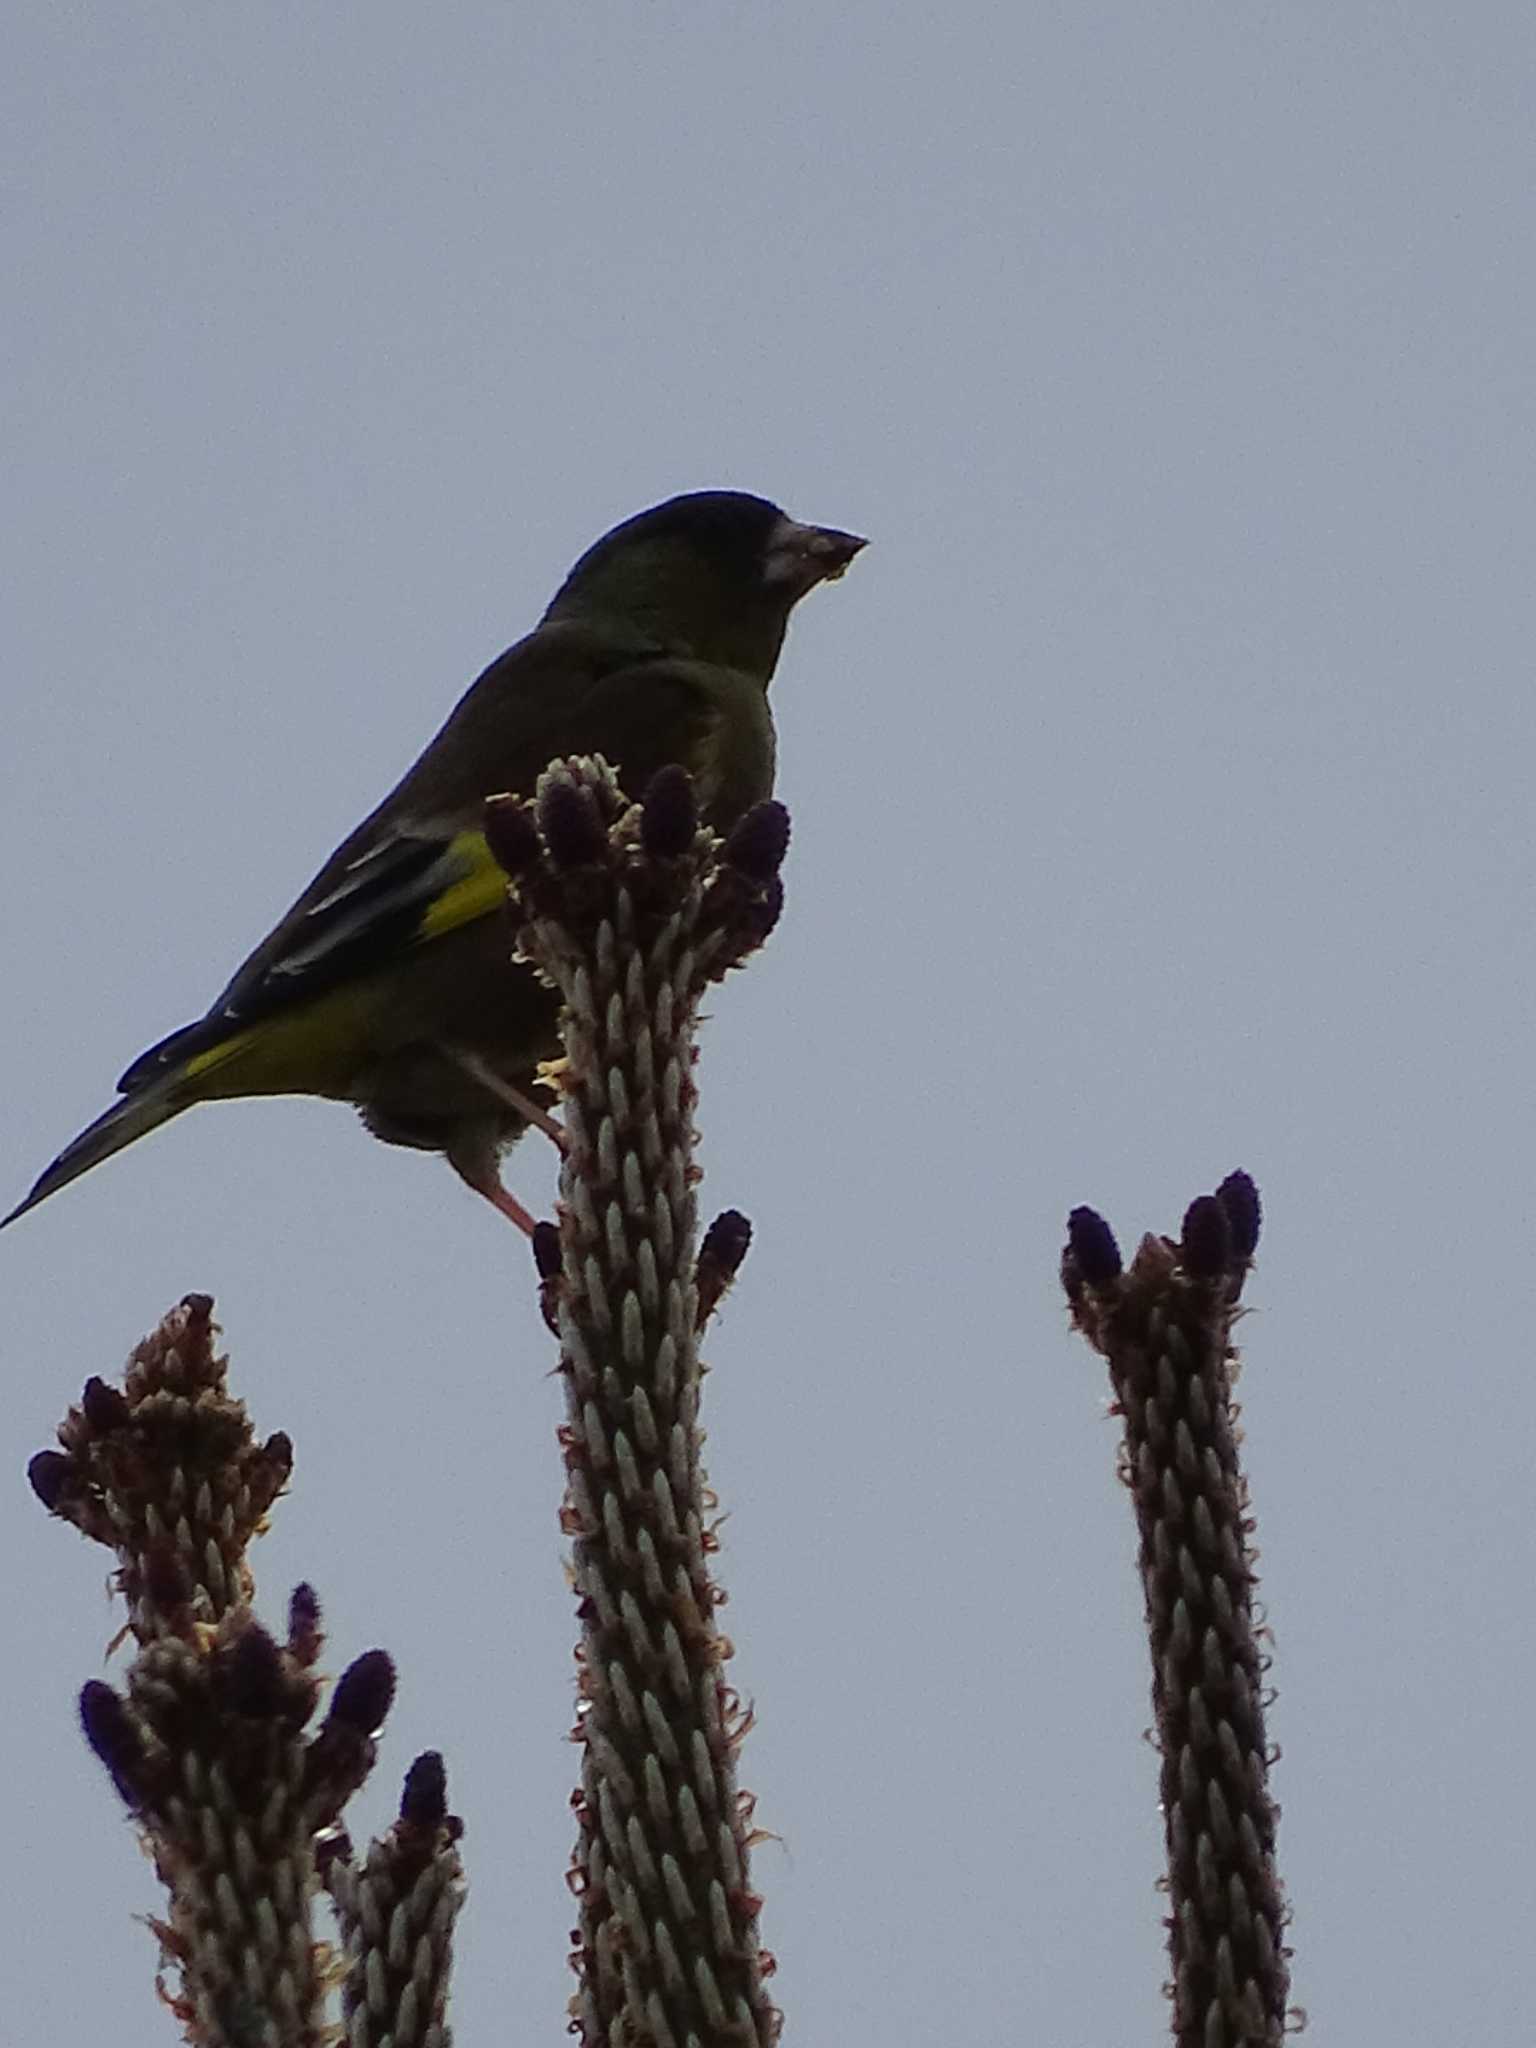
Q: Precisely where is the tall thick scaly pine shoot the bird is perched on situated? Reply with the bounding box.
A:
[487,760,788,2048]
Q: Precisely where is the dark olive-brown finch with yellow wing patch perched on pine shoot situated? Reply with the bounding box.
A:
[2,492,864,1229]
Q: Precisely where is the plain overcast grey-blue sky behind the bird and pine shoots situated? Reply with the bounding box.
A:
[0,0,1536,2048]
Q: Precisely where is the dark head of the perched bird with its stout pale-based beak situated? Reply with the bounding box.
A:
[545,492,864,684]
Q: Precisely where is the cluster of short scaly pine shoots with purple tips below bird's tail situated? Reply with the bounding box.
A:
[29,1294,463,2048]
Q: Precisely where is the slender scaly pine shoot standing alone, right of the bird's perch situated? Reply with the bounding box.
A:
[1063,1174,1290,2048]
